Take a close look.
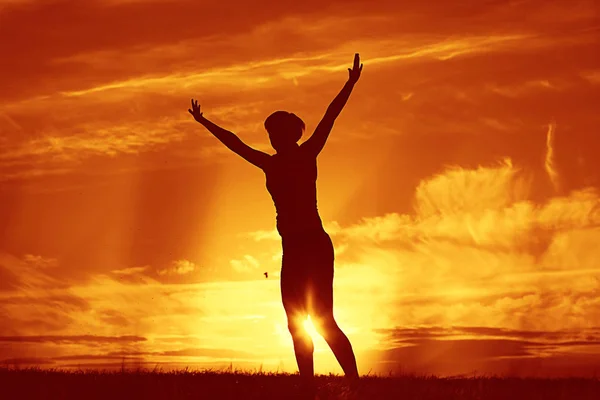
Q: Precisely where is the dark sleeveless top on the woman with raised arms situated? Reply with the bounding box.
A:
[264,147,323,237]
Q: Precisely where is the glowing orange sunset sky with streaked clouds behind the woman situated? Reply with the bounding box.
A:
[0,0,600,376]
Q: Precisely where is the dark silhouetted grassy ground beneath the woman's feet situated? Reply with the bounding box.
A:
[0,368,600,400]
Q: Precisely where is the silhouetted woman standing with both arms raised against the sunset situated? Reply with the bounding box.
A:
[188,53,362,391]
